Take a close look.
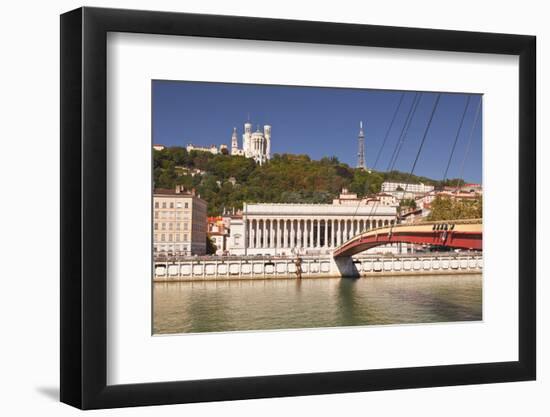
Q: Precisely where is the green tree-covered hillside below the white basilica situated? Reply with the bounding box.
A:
[153,147,464,215]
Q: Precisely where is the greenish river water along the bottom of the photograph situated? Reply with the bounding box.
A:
[153,274,482,334]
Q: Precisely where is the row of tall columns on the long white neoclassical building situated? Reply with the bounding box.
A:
[245,217,395,249]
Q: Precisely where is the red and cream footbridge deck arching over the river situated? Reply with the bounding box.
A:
[333,219,483,258]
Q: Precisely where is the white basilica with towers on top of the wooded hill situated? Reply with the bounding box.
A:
[231,122,271,165]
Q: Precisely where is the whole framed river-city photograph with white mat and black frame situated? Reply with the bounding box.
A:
[60,8,536,409]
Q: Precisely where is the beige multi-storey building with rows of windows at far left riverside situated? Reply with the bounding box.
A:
[153,186,207,257]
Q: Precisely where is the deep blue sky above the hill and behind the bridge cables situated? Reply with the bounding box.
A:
[153,81,482,183]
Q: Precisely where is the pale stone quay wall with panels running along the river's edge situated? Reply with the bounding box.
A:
[154,252,483,281]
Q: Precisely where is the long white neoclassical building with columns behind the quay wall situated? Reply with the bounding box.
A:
[228,191,397,255]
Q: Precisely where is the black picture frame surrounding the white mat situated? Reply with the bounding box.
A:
[60,7,536,409]
